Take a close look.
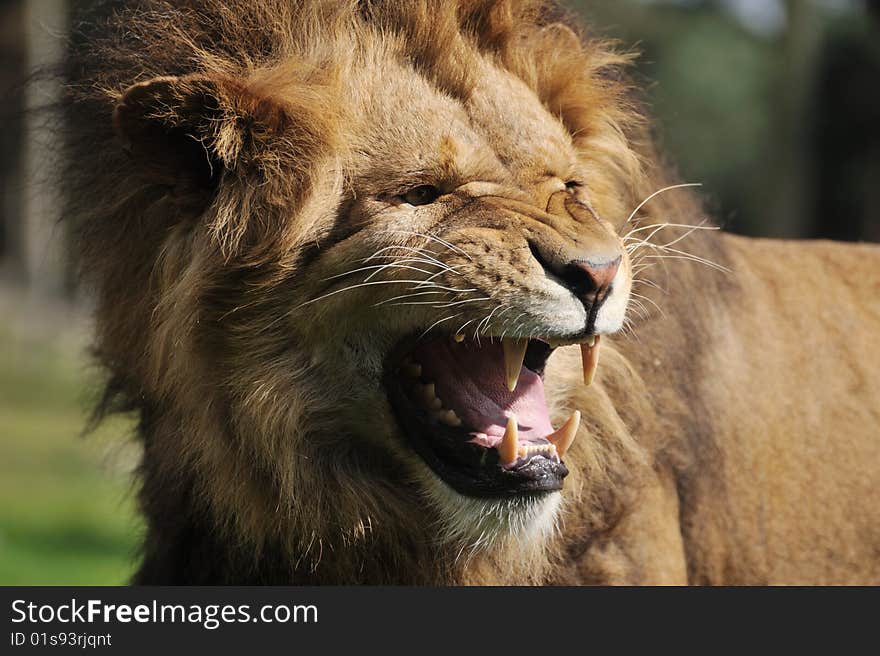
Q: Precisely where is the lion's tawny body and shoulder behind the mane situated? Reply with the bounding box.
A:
[544,236,880,584]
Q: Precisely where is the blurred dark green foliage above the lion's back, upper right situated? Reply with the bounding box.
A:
[569,0,880,240]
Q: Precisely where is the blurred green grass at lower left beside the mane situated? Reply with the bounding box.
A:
[0,331,141,585]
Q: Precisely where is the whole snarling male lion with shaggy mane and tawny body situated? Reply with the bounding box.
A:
[66,0,880,584]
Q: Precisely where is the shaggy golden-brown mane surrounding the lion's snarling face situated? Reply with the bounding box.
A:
[66,0,728,583]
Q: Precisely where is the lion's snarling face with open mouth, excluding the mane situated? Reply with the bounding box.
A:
[287,57,631,532]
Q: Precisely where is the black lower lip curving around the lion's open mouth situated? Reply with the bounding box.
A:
[384,336,568,498]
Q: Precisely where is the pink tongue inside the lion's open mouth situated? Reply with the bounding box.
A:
[412,339,553,446]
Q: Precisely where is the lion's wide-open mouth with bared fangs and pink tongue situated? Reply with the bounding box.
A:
[386,335,599,497]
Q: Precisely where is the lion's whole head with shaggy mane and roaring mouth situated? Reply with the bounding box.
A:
[67,0,660,580]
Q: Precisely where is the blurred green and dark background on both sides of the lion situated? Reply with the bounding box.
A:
[0,0,880,584]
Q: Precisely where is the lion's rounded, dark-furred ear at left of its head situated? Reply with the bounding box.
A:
[113,75,284,203]
